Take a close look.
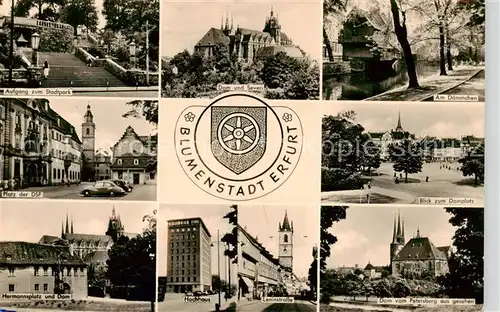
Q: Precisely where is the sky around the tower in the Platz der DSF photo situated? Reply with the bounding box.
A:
[50,98,157,152]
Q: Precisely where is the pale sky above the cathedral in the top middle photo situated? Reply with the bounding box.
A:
[161,0,322,59]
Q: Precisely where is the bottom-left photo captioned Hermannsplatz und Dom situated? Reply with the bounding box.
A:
[0,201,157,312]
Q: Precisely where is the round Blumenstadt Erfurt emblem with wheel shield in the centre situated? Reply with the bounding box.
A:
[175,93,303,201]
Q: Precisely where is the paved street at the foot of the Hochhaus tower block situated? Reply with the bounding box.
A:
[158,293,235,312]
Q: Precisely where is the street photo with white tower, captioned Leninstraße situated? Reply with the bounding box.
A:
[238,205,319,312]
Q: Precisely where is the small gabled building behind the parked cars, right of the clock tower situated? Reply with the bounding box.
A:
[110,126,158,184]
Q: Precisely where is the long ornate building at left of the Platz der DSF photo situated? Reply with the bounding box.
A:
[0,98,82,186]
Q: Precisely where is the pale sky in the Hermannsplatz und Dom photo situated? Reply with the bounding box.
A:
[0,200,157,242]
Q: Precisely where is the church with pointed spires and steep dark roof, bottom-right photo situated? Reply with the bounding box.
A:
[390,212,450,278]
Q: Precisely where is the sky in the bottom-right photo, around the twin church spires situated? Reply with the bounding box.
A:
[327,205,466,268]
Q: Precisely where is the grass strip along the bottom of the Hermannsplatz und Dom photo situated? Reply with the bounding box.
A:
[0,300,151,312]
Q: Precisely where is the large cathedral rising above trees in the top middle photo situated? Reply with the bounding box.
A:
[194,9,304,63]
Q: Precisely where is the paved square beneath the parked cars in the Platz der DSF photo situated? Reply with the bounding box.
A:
[11,182,156,201]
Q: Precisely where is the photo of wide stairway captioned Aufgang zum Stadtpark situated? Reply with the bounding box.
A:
[0,0,160,97]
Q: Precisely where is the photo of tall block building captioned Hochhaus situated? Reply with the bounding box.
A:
[158,204,239,312]
